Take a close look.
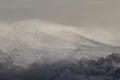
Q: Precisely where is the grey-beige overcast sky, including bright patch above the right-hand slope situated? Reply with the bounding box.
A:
[0,0,120,45]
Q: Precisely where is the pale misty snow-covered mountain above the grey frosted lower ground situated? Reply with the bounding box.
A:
[0,20,112,48]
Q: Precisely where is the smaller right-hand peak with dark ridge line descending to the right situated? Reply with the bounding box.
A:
[55,31,110,47]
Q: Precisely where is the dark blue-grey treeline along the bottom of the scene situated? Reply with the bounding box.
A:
[0,53,120,80]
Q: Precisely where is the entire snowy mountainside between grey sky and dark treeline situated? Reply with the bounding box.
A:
[0,20,119,66]
